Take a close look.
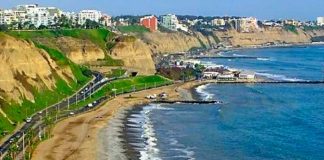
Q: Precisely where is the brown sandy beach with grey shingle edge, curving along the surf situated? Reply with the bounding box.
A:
[32,82,201,160]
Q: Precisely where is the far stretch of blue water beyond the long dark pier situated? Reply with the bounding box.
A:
[202,46,324,81]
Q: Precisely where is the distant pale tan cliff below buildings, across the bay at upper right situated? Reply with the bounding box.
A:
[214,27,311,47]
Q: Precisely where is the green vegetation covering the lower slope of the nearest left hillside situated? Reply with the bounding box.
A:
[0,44,90,138]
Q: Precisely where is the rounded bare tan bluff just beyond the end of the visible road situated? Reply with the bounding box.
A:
[111,39,156,75]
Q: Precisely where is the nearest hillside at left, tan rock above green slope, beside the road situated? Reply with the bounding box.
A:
[0,33,89,136]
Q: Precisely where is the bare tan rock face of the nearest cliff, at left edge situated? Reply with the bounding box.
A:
[0,33,75,103]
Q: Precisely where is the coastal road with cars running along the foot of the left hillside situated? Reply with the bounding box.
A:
[0,72,111,158]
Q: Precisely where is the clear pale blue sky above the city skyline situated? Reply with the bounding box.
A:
[0,0,324,20]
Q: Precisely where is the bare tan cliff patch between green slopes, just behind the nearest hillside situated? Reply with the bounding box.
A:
[38,37,105,64]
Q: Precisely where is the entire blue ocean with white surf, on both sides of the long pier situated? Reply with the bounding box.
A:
[124,46,324,160]
